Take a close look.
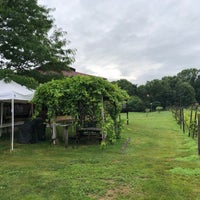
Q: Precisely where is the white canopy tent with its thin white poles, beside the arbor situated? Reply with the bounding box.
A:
[0,80,34,150]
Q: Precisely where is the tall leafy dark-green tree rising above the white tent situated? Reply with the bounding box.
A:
[0,0,74,70]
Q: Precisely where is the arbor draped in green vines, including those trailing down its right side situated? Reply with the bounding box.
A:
[33,76,128,144]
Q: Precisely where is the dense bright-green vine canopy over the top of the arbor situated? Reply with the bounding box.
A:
[33,76,128,118]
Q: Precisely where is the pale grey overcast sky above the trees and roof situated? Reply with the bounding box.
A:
[38,0,200,85]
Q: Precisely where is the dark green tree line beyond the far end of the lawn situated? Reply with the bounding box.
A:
[114,68,200,111]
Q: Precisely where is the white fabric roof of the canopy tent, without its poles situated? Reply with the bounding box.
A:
[0,80,34,101]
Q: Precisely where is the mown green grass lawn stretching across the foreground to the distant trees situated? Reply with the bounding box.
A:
[0,112,200,200]
